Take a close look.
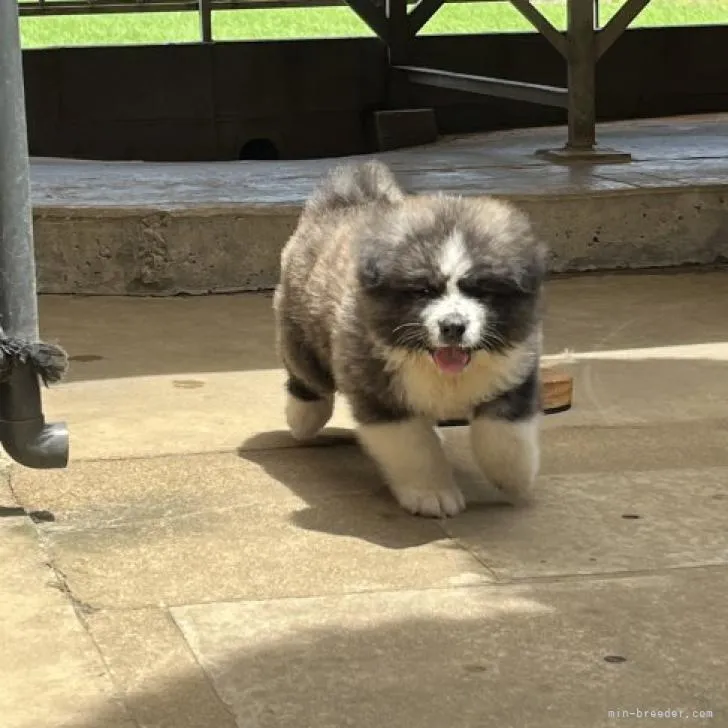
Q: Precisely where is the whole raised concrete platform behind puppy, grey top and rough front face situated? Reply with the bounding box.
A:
[32,115,728,295]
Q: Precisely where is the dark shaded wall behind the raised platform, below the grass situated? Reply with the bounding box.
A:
[19,27,728,161]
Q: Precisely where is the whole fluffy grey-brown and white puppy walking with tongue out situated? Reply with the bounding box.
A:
[274,162,545,517]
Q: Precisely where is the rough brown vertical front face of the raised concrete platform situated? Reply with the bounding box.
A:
[34,185,728,295]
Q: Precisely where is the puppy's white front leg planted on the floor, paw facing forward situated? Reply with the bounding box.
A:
[359,418,465,517]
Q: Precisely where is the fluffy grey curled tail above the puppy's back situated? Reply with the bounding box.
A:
[306,161,404,212]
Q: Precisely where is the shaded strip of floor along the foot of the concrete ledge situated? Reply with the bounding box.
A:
[40,272,728,382]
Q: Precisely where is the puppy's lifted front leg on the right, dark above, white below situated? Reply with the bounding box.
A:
[470,368,541,501]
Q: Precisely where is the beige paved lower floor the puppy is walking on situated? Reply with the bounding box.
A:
[0,272,728,728]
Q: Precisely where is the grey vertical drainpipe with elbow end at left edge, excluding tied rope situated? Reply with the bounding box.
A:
[0,0,68,468]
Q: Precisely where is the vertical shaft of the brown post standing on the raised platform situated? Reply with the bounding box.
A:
[566,0,597,151]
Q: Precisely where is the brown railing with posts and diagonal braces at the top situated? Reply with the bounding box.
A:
[18,0,650,163]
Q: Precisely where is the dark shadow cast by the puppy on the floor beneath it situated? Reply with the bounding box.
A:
[238,428,509,549]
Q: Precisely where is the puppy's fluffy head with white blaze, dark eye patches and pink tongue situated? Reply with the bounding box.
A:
[358,196,545,374]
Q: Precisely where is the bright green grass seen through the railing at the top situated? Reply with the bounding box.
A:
[18,0,728,48]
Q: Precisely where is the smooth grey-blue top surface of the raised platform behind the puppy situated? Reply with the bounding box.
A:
[32,114,728,212]
